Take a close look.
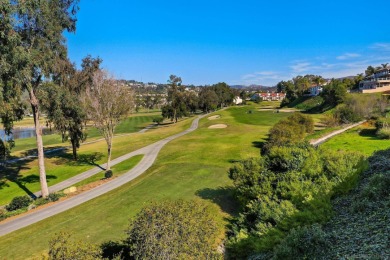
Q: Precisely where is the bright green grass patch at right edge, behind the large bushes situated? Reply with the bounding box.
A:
[321,126,390,156]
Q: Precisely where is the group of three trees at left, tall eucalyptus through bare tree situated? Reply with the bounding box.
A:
[0,0,133,197]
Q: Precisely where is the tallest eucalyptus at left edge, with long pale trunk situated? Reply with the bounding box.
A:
[0,0,78,197]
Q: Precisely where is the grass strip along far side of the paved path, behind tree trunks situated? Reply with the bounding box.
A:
[0,114,191,205]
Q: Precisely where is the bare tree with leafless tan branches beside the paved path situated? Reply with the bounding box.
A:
[84,70,134,170]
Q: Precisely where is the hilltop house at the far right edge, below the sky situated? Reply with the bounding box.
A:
[359,68,390,93]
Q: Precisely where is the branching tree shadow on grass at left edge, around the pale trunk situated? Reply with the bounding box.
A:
[0,159,57,199]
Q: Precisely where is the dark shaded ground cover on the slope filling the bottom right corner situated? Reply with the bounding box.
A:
[266,149,390,259]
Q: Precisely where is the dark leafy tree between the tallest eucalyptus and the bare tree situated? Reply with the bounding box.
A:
[41,55,102,160]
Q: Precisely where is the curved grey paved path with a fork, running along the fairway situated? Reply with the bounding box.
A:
[0,115,206,236]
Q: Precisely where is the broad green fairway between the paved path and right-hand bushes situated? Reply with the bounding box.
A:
[0,104,288,259]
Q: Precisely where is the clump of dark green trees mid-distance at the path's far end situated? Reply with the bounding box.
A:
[162,75,236,122]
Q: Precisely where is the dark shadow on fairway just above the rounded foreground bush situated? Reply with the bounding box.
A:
[195,186,240,216]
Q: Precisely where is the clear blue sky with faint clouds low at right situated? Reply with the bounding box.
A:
[66,0,390,86]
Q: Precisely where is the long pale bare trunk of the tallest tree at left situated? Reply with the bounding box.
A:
[29,89,49,198]
